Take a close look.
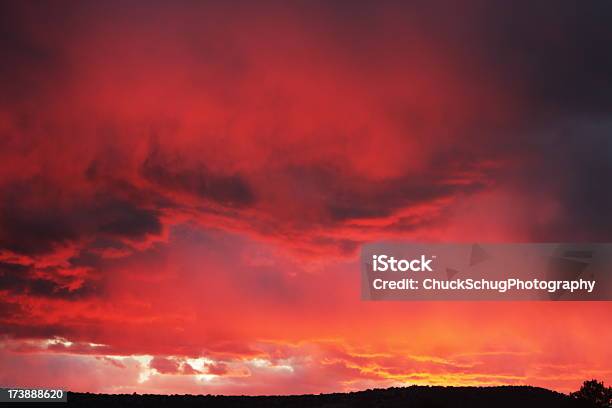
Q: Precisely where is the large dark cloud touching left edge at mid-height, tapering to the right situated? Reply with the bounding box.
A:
[0,178,162,254]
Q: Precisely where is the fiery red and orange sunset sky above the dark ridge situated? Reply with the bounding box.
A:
[0,0,612,395]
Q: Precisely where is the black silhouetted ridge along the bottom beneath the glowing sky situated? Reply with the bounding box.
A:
[54,386,591,408]
